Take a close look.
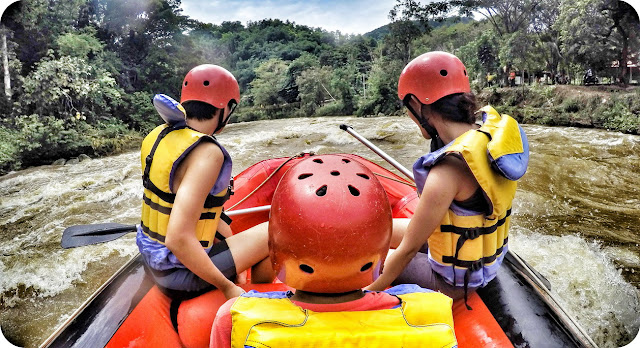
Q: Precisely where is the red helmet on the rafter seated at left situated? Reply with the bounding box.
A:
[180,64,240,109]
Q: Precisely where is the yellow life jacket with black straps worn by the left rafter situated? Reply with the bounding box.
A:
[141,124,231,248]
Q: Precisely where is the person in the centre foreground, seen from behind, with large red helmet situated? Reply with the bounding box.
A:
[210,155,457,348]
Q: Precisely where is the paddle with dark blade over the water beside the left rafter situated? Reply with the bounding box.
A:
[60,205,271,249]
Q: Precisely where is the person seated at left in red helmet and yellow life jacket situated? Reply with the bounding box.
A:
[136,64,273,305]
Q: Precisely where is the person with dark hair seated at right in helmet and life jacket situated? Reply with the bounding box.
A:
[367,51,529,308]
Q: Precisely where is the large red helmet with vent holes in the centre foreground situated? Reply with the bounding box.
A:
[269,155,392,293]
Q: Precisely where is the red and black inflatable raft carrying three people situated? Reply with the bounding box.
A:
[41,154,595,348]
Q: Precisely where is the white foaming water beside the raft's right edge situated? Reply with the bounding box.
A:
[509,228,640,347]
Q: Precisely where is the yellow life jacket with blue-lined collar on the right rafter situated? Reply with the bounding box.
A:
[414,106,529,289]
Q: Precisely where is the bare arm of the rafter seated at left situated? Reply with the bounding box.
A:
[165,143,242,298]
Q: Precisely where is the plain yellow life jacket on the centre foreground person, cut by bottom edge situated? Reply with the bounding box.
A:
[231,285,457,348]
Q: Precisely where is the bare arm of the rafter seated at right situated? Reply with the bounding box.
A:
[366,159,466,291]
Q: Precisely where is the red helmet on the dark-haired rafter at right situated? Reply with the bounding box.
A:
[398,51,471,104]
